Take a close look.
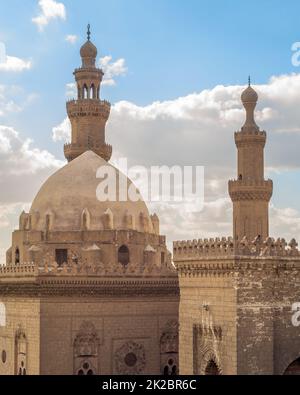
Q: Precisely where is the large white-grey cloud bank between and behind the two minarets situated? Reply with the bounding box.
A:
[53,74,300,246]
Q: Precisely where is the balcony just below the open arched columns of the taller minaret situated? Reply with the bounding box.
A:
[67,99,111,121]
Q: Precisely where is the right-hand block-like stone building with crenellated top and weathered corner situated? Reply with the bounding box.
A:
[174,238,300,374]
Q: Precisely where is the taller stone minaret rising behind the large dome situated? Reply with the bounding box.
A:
[64,25,112,162]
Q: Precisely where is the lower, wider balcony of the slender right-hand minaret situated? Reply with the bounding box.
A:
[228,180,273,202]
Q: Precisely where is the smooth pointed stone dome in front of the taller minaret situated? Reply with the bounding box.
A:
[30,151,154,233]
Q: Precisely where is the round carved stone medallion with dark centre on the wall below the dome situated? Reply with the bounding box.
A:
[114,341,146,375]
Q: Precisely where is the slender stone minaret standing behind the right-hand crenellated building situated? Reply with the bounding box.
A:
[229,78,273,241]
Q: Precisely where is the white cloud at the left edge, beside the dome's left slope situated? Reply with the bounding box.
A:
[0,125,65,264]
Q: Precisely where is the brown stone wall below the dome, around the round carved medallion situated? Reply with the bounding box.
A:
[41,297,178,375]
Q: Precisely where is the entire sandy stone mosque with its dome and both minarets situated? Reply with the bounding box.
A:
[0,34,300,375]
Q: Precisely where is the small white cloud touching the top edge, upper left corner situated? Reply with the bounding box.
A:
[32,0,66,31]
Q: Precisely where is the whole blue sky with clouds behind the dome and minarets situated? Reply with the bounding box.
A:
[0,0,300,261]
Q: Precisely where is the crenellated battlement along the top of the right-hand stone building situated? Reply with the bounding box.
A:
[173,236,300,262]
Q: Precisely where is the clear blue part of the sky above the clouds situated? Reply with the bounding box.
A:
[0,0,300,153]
